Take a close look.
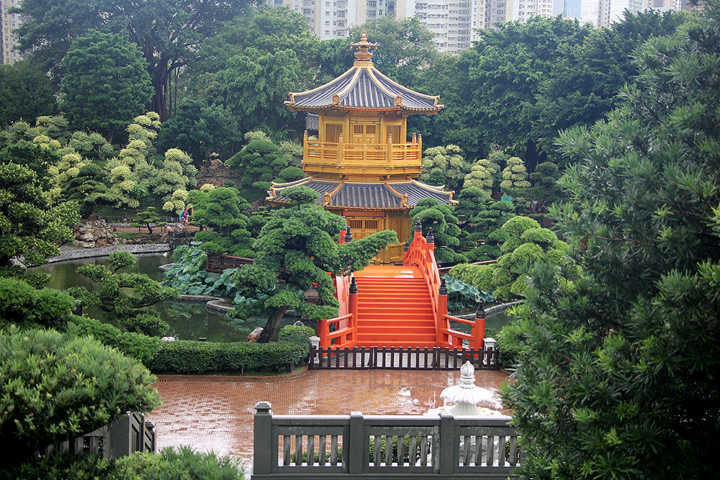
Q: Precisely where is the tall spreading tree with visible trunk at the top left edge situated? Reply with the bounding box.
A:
[19,0,247,120]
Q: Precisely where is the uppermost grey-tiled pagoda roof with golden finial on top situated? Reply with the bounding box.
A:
[285,32,443,113]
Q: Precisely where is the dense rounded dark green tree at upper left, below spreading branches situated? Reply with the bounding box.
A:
[60,30,152,141]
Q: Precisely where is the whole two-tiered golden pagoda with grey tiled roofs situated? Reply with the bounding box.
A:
[268,32,454,263]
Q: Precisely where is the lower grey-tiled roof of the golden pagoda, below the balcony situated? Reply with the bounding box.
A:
[267,177,456,210]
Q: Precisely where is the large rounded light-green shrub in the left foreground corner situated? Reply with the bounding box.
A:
[0,326,159,461]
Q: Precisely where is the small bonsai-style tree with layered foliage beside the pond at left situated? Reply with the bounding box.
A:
[74,252,177,335]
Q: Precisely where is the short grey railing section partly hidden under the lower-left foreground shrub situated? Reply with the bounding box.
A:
[45,413,155,458]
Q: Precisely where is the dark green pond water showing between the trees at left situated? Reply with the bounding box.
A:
[37,254,265,342]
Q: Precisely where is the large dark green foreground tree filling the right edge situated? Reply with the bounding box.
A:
[501,1,720,479]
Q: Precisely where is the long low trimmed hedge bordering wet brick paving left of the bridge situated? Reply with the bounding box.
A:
[147,340,308,373]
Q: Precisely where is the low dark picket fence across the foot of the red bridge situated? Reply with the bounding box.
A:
[308,346,500,370]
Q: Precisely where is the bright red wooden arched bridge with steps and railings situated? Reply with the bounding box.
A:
[318,230,485,350]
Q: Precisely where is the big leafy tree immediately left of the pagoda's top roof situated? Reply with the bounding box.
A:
[186,7,316,137]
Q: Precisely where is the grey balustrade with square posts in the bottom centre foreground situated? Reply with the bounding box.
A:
[252,402,520,480]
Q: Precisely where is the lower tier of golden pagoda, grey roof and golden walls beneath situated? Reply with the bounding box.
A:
[267,177,456,264]
